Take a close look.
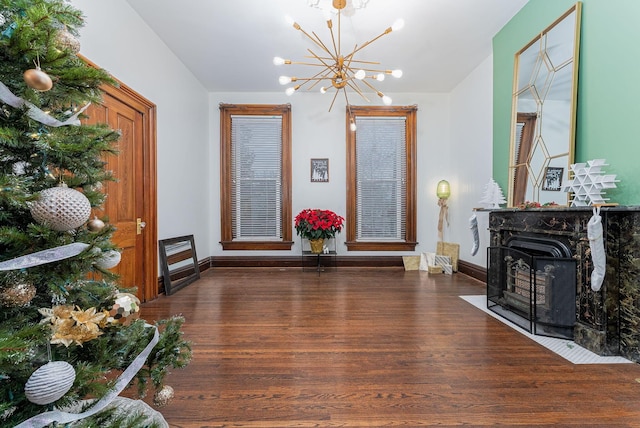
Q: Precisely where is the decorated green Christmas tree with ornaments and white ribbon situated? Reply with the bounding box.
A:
[0,0,191,427]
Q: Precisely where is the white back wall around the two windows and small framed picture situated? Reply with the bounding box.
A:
[210,92,452,256]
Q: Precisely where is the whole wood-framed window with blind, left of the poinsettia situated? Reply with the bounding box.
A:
[220,104,293,250]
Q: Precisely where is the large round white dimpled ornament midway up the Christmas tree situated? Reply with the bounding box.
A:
[31,185,91,232]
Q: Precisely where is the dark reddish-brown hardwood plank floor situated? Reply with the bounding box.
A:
[142,268,640,428]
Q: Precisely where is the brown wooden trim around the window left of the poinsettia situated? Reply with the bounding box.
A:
[220,103,293,251]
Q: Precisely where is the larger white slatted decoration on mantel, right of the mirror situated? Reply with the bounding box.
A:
[563,159,620,207]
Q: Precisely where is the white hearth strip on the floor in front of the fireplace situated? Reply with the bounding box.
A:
[460,295,631,364]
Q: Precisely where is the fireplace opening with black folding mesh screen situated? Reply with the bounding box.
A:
[487,233,576,339]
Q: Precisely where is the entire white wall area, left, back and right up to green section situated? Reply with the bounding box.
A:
[72,0,492,266]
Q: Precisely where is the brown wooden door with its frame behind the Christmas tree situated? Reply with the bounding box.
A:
[87,78,158,302]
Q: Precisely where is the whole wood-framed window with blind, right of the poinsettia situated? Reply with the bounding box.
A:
[346,106,417,251]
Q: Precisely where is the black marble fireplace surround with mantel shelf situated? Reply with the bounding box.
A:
[487,206,640,362]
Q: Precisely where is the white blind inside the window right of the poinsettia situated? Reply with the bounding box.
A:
[356,116,407,241]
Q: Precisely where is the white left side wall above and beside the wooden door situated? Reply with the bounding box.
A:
[72,0,212,258]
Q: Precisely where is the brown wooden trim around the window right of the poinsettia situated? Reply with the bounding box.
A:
[345,105,418,251]
